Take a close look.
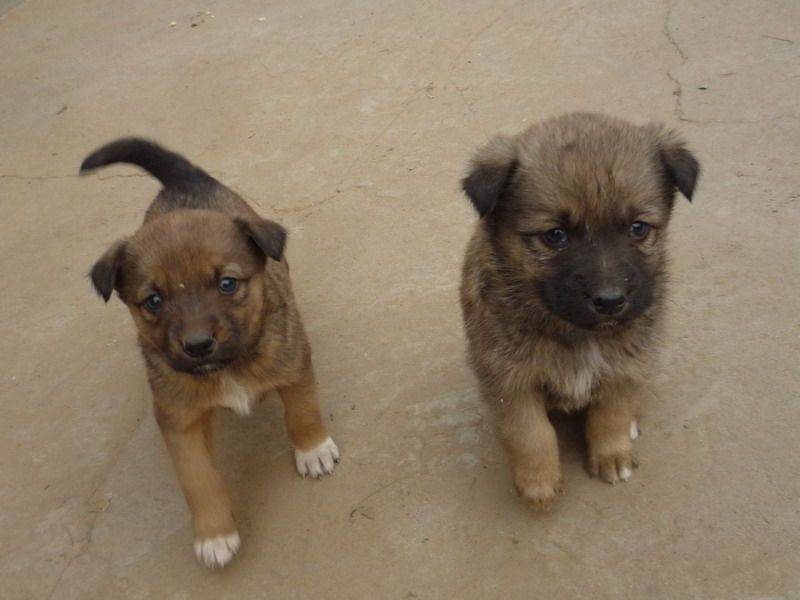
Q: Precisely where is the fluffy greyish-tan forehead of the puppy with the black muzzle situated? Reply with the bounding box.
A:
[517,118,668,227]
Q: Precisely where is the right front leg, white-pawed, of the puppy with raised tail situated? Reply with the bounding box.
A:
[278,367,339,478]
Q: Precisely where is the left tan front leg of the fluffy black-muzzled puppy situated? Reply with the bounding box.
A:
[492,392,562,509]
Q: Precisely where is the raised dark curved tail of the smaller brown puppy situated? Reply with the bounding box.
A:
[80,137,215,188]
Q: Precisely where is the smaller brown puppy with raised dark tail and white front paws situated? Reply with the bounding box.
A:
[81,139,339,567]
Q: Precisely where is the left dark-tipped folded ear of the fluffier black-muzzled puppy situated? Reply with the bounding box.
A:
[461,136,518,217]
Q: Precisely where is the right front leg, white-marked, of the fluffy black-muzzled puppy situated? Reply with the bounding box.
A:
[586,379,639,483]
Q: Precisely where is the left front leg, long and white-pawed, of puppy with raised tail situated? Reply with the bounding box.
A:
[156,408,239,569]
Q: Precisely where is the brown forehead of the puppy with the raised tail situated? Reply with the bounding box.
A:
[132,210,257,288]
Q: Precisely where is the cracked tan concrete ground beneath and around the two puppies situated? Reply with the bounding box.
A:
[0,0,800,599]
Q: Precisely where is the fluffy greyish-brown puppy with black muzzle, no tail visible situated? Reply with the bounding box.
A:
[461,114,699,507]
